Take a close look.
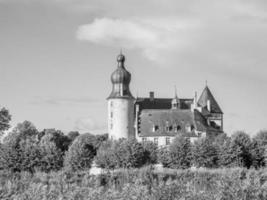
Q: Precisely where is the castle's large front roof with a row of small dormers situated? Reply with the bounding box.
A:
[138,109,209,137]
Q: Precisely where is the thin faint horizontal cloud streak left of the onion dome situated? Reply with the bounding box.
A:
[30,97,97,106]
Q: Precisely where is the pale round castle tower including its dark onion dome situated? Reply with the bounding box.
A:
[107,53,135,140]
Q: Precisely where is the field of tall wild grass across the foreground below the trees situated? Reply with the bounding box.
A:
[0,167,267,200]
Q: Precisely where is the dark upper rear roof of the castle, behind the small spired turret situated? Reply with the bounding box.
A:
[135,97,194,110]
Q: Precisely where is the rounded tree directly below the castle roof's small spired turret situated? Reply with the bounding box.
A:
[169,136,192,169]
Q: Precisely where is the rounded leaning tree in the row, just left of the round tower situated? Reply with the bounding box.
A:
[64,133,96,171]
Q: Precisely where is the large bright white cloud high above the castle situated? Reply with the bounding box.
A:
[77,18,196,60]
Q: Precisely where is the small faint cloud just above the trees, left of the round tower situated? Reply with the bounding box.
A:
[74,117,106,134]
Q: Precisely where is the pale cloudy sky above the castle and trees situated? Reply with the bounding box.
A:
[0,0,267,134]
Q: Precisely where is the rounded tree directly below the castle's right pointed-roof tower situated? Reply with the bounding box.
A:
[192,138,218,168]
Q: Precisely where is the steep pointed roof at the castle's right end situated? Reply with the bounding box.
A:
[198,86,223,114]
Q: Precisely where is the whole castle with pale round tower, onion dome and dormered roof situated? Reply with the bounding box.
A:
[107,54,223,146]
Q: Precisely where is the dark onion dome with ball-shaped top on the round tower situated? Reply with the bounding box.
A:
[108,53,134,99]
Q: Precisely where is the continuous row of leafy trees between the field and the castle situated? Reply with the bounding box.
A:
[0,106,267,173]
